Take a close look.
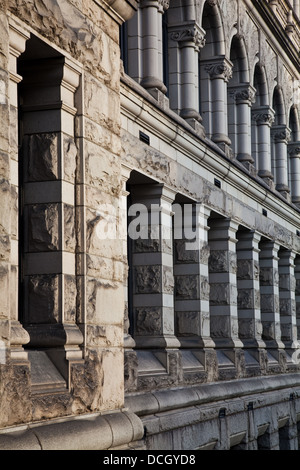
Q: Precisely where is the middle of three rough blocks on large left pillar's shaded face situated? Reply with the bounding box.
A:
[28,204,59,252]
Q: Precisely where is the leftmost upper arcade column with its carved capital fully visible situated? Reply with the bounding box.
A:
[169,24,205,136]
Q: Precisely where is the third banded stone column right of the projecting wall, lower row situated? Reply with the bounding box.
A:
[209,218,243,376]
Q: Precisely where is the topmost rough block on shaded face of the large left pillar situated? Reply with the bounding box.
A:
[23,133,59,181]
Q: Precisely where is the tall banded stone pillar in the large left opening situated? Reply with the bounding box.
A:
[20,57,83,380]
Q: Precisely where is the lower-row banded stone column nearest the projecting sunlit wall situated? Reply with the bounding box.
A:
[128,184,180,349]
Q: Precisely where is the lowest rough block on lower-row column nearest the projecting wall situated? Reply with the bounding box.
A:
[135,307,162,336]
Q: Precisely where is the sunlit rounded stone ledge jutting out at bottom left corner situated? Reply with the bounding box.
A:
[0,411,144,450]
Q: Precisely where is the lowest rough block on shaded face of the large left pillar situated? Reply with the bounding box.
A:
[25,274,60,323]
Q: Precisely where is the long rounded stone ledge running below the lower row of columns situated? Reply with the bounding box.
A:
[125,373,300,417]
